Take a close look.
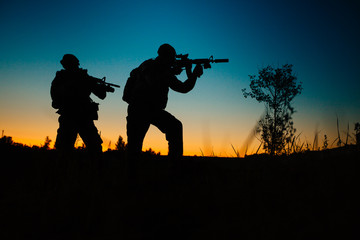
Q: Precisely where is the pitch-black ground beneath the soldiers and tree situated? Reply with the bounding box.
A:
[0,145,360,240]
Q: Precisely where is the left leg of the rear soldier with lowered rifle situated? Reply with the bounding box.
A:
[55,116,77,152]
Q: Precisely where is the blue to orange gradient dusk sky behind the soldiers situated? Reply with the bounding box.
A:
[0,0,360,156]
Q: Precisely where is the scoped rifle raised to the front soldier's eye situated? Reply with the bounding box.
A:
[174,54,229,75]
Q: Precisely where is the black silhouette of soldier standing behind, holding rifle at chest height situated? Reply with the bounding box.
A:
[50,54,113,153]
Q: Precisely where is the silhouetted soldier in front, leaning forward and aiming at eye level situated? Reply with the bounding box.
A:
[123,44,203,160]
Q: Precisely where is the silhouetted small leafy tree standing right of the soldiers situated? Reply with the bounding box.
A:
[242,64,302,155]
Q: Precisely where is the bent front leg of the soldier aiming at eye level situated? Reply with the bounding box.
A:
[151,110,183,160]
